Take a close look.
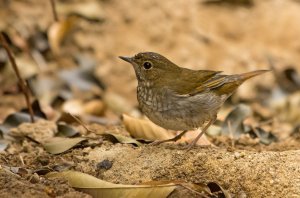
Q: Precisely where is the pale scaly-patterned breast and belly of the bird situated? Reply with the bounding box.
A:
[137,83,221,130]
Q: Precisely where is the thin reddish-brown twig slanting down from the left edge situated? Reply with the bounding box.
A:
[0,33,34,123]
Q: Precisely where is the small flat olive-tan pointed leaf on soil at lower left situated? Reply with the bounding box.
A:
[43,137,86,154]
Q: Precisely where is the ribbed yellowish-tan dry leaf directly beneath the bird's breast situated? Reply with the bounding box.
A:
[123,114,173,140]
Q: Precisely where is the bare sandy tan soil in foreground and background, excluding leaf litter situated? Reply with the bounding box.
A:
[0,0,300,198]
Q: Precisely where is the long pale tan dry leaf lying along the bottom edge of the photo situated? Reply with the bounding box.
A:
[46,171,176,198]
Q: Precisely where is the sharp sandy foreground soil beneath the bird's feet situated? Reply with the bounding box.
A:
[0,121,300,197]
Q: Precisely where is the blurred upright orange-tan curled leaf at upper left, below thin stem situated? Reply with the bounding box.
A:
[48,16,76,54]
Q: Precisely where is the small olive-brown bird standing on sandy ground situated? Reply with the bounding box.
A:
[119,52,269,150]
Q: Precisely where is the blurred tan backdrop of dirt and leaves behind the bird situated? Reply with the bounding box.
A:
[0,0,300,142]
